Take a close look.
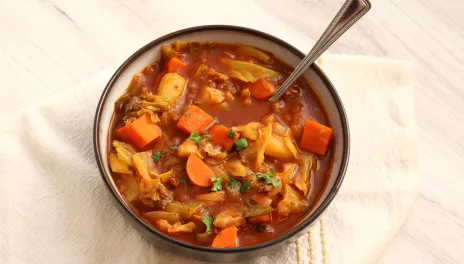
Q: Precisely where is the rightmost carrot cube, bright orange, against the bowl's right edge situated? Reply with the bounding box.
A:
[300,120,333,155]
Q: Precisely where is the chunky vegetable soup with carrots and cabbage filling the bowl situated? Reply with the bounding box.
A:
[108,42,333,248]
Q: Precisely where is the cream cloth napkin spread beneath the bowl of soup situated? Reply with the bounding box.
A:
[0,56,418,264]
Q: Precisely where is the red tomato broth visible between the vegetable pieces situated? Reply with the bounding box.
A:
[108,41,333,246]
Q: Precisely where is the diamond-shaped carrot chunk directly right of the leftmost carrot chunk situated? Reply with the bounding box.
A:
[177,105,214,135]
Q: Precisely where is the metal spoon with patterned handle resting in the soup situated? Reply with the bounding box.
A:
[269,0,371,102]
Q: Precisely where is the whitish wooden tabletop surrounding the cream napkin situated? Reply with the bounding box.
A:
[0,0,464,264]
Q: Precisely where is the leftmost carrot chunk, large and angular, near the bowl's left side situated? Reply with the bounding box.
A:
[117,115,161,149]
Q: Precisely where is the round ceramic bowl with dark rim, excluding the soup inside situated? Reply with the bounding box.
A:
[93,25,349,262]
